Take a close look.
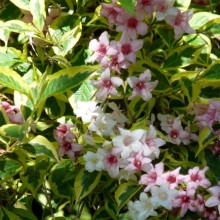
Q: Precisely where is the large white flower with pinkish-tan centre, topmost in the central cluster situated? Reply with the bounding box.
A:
[112,128,144,159]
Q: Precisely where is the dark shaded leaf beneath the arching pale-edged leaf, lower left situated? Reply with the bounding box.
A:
[20,156,50,197]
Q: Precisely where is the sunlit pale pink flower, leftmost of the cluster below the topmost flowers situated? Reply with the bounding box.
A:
[87,31,118,65]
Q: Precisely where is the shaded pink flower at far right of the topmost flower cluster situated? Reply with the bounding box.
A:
[165,9,195,39]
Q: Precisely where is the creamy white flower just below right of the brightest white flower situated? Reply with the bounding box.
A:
[88,113,117,136]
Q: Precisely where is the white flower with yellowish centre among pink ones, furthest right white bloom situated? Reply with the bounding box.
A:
[151,183,178,210]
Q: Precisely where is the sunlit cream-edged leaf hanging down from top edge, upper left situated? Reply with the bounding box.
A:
[30,0,46,31]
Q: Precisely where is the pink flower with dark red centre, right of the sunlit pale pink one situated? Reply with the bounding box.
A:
[118,32,143,63]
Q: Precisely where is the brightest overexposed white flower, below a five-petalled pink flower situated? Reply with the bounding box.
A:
[73,101,101,123]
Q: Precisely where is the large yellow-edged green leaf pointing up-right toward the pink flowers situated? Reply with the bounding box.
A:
[39,66,98,102]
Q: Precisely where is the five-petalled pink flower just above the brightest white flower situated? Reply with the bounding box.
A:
[91,69,123,100]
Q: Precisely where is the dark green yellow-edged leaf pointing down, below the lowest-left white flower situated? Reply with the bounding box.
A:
[74,169,102,201]
